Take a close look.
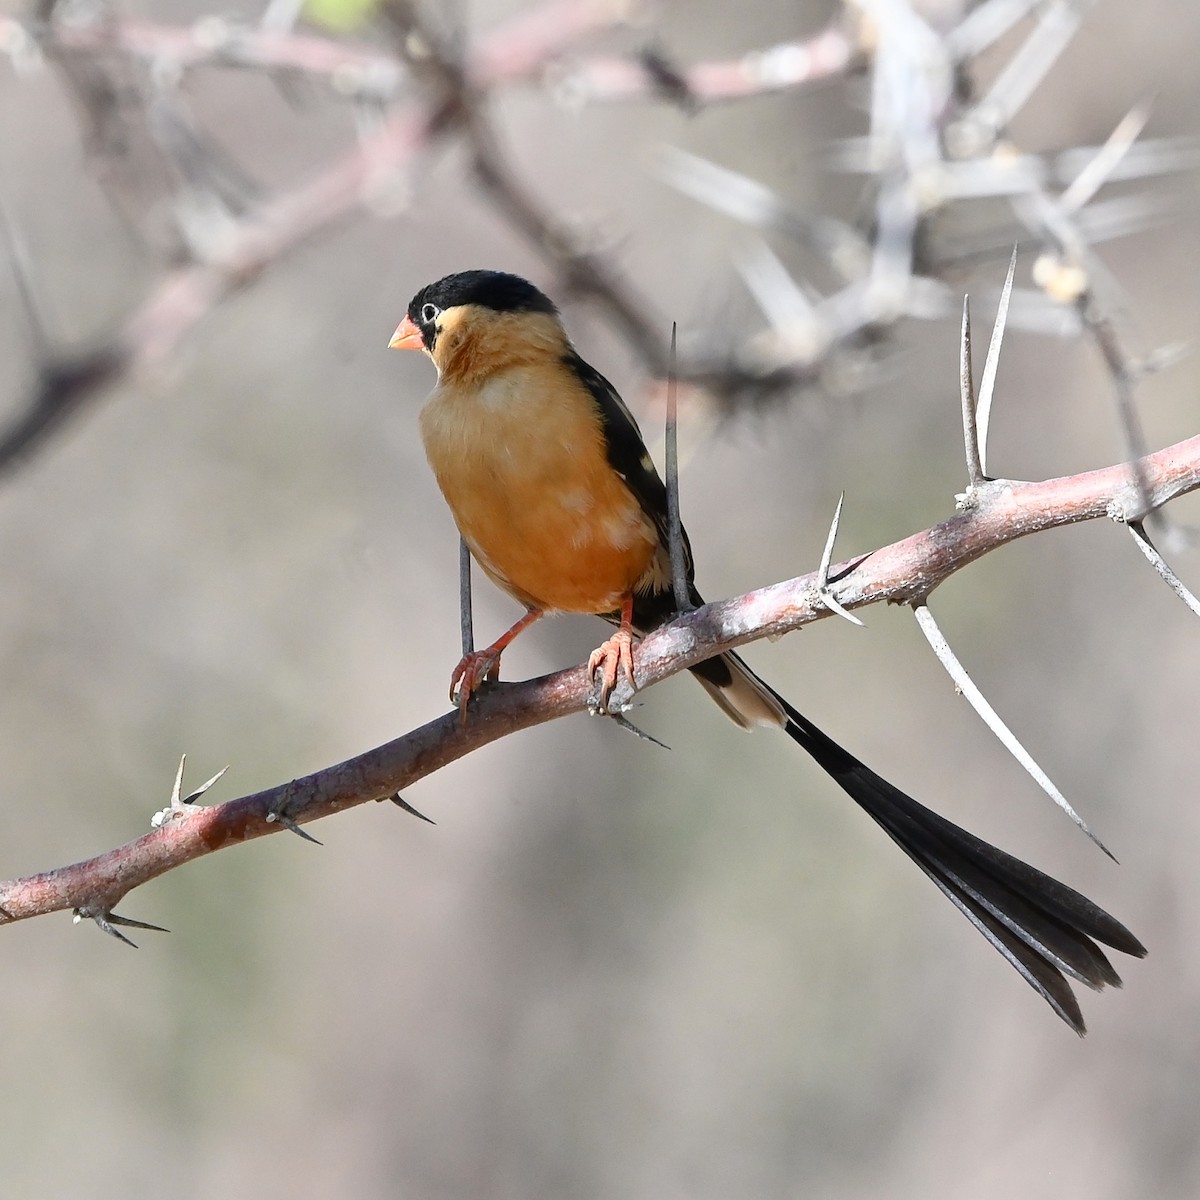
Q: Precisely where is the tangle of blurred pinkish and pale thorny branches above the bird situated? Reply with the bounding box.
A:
[7,0,1195,472]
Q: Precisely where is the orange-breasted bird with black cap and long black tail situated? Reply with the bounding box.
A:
[389,270,1146,1037]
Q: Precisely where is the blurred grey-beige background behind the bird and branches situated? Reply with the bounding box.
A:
[0,0,1200,1200]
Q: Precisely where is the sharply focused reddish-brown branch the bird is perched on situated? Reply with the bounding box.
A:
[7,437,1200,923]
